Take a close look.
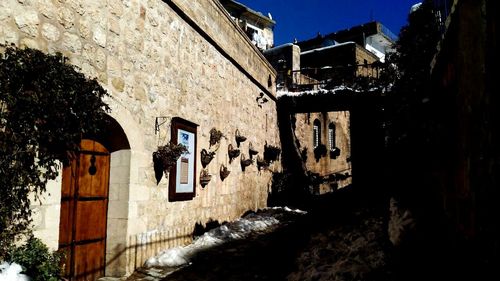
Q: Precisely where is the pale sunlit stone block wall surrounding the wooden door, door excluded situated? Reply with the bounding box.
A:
[0,0,280,276]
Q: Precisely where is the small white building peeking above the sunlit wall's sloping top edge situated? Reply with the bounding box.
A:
[220,0,276,50]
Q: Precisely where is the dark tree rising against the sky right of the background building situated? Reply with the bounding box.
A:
[386,0,440,151]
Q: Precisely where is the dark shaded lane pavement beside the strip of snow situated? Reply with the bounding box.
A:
[104,186,393,281]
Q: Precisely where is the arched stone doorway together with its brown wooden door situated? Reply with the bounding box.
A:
[59,116,130,280]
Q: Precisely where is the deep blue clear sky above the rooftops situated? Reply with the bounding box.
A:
[236,0,420,46]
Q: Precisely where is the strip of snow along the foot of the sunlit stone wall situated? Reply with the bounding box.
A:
[145,207,305,267]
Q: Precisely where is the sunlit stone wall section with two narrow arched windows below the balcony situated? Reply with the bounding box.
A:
[295,111,352,193]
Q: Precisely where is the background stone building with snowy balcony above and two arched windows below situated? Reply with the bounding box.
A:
[264,22,395,193]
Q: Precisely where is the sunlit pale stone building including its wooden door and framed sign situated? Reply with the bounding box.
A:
[0,0,280,279]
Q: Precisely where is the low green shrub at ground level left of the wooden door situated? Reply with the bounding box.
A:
[7,236,62,281]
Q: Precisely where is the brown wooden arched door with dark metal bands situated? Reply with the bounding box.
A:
[59,140,109,281]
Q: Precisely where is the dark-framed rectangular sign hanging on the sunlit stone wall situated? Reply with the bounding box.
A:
[168,117,198,201]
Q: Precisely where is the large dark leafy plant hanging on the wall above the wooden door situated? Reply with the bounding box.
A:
[0,46,109,258]
